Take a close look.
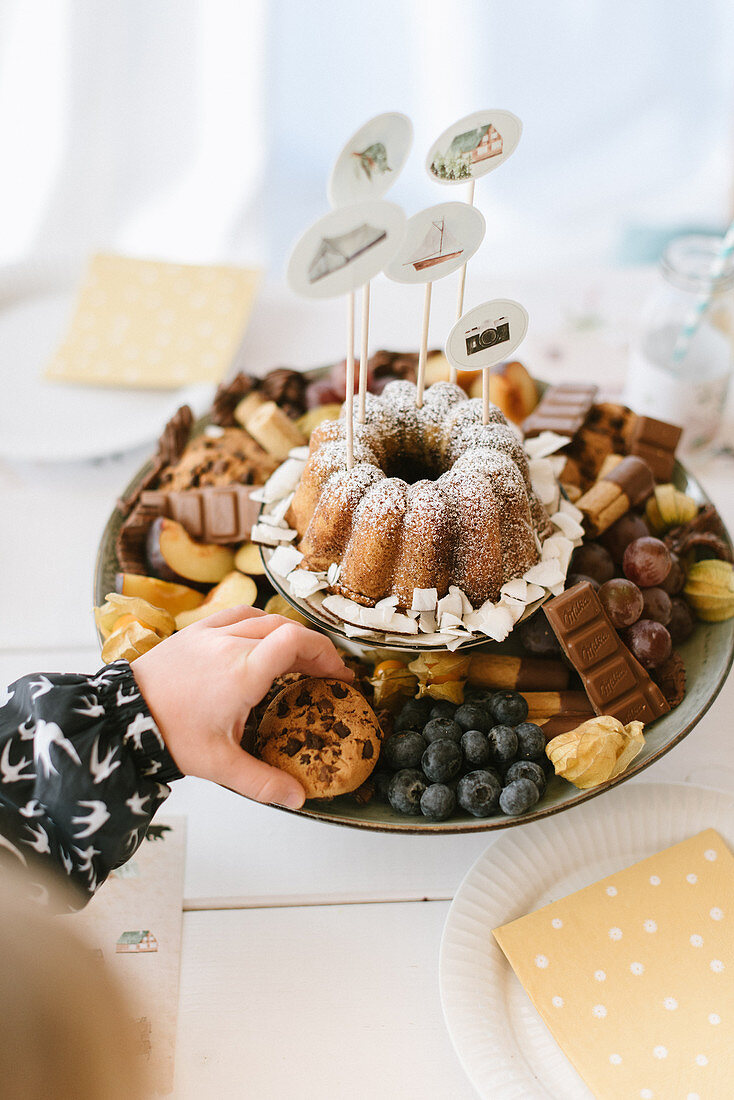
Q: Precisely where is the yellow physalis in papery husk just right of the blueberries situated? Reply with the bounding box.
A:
[546,714,645,790]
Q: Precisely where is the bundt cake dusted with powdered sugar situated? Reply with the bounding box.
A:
[287,381,550,608]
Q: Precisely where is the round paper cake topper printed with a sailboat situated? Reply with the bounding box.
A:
[385,202,484,283]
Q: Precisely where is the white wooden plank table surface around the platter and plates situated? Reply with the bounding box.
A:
[0,261,734,1100]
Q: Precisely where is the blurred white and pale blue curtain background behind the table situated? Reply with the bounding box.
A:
[0,0,734,279]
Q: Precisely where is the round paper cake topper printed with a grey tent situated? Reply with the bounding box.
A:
[286,199,405,298]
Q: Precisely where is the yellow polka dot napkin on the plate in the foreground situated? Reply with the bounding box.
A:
[494,829,734,1100]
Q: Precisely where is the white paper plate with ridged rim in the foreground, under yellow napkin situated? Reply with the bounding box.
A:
[439,782,734,1100]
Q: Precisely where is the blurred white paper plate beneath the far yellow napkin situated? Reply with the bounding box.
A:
[0,267,212,462]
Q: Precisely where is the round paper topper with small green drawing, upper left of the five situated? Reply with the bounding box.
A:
[327,111,413,207]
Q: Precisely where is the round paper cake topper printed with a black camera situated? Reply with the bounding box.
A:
[446,298,527,371]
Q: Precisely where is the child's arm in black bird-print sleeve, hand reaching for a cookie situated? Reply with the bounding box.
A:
[0,607,352,905]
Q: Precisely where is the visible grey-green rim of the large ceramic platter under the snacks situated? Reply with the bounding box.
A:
[94,418,734,834]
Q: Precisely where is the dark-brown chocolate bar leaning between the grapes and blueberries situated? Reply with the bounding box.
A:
[544,581,670,725]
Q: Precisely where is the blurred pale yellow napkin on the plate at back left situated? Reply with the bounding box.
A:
[45,255,260,389]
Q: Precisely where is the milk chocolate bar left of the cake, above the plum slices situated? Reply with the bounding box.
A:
[141,485,260,543]
